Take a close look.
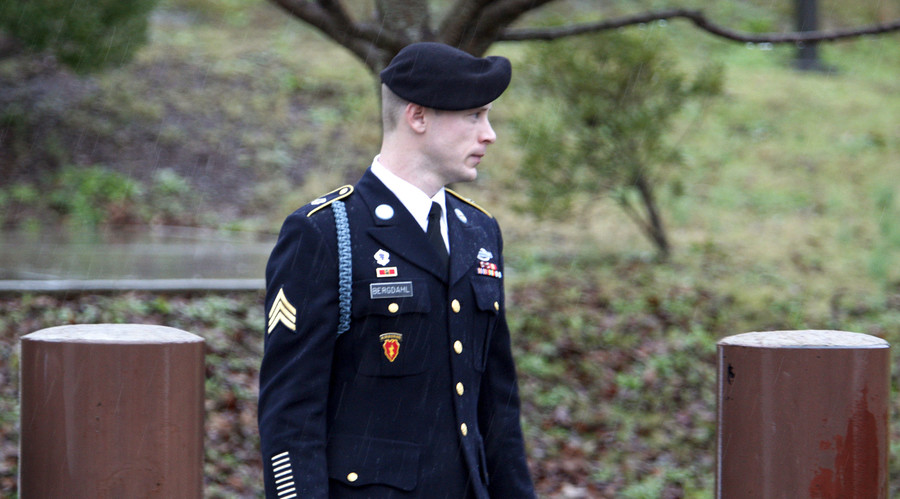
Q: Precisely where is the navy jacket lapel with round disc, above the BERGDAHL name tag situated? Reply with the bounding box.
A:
[356,170,452,280]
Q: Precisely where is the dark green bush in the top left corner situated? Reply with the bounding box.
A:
[0,0,158,73]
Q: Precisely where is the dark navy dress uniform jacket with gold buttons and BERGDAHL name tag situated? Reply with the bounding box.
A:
[259,171,534,499]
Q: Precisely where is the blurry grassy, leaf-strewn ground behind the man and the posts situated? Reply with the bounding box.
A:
[0,0,900,498]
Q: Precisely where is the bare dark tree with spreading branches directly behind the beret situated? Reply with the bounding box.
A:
[270,0,900,74]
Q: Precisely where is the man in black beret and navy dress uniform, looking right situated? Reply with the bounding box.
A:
[259,43,534,499]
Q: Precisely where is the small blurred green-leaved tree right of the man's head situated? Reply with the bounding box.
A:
[517,30,722,258]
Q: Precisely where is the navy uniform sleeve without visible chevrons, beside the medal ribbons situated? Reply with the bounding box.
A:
[479,223,535,498]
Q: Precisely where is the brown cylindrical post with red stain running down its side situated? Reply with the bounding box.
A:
[716,331,890,499]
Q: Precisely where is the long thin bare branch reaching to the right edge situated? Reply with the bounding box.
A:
[497,9,900,43]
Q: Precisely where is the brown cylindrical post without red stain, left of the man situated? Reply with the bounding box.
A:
[19,324,205,499]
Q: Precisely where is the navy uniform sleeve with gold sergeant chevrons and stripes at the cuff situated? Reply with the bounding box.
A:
[258,210,339,499]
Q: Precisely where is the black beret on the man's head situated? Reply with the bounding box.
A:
[381,42,512,111]
